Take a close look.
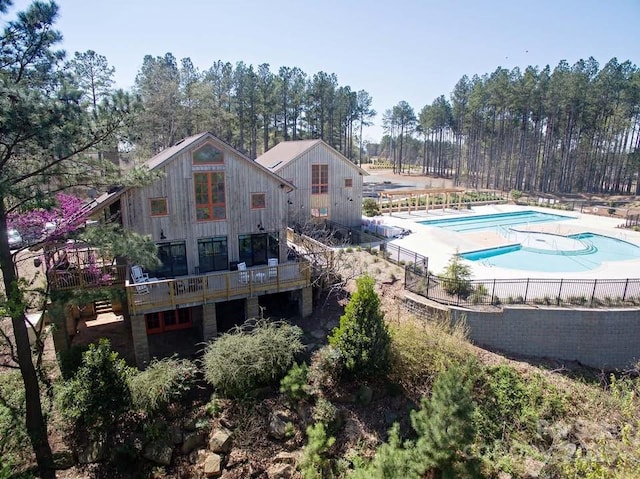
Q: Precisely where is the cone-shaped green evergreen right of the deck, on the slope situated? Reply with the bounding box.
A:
[329,276,391,377]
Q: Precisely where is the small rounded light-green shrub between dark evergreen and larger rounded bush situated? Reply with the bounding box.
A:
[129,357,198,414]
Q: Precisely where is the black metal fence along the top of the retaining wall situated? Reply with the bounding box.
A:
[405,265,640,308]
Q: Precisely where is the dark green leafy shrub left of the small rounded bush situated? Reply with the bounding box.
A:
[57,338,131,432]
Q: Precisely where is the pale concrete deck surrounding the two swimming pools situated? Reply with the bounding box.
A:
[376,205,640,279]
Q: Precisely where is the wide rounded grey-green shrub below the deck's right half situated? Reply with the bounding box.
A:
[203,320,304,397]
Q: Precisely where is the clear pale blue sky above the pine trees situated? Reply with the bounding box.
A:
[5,0,640,141]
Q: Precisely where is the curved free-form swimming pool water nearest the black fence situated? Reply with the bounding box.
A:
[460,233,640,272]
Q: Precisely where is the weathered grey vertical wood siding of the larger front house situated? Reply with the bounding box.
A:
[122,138,287,274]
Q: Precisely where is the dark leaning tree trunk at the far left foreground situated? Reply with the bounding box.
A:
[0,202,56,479]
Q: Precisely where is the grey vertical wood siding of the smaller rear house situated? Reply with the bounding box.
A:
[277,143,363,227]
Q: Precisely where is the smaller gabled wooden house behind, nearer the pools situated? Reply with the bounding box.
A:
[256,140,368,228]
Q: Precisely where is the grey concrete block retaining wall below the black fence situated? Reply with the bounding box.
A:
[404,294,640,370]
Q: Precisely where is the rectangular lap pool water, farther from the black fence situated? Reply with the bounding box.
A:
[420,210,573,233]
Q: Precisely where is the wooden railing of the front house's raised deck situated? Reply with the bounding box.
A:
[125,261,310,314]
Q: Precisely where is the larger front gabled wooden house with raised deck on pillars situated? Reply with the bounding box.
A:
[51,133,312,366]
